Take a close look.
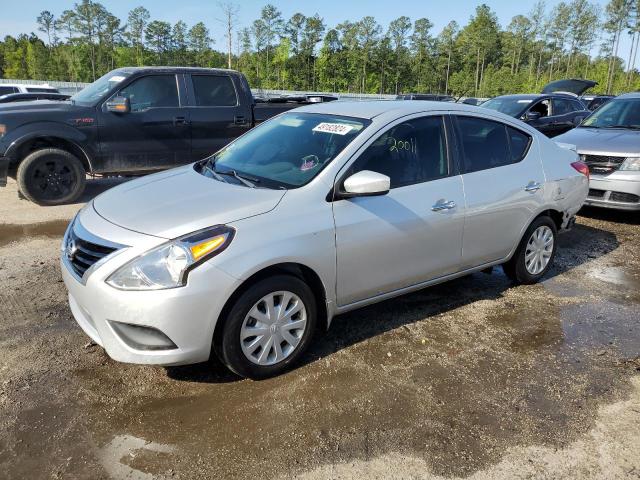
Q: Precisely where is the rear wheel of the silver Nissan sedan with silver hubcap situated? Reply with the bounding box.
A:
[502,216,558,285]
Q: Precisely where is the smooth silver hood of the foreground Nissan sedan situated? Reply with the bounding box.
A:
[93,165,286,238]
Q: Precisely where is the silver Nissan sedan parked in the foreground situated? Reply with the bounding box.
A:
[61,101,588,378]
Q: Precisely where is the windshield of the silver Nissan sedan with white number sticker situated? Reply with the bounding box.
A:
[201,112,371,188]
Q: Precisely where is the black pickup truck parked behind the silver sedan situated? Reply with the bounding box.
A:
[0,67,329,205]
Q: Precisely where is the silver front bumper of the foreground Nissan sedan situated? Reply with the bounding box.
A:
[60,213,239,366]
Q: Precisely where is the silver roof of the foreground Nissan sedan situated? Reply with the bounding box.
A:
[295,100,490,120]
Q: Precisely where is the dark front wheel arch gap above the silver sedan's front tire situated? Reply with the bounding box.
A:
[213,262,329,350]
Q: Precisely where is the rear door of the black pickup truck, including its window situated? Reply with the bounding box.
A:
[187,73,253,161]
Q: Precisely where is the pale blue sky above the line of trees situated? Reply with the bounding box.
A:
[0,0,631,64]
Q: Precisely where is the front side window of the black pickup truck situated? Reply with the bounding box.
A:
[120,75,179,112]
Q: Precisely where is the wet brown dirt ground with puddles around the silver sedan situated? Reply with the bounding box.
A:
[0,177,640,480]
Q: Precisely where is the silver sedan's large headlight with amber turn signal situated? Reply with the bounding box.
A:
[107,225,235,290]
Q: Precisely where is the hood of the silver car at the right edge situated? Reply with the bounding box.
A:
[554,127,640,156]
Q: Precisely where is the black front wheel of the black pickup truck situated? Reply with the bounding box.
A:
[16,148,86,205]
